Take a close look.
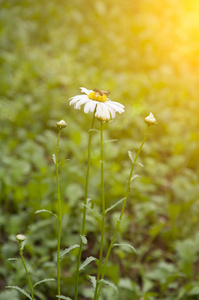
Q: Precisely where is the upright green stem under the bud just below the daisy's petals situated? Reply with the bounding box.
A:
[94,121,105,299]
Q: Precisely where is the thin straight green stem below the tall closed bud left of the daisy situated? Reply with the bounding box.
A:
[56,128,62,296]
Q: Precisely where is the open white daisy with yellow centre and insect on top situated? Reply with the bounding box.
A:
[69,87,124,121]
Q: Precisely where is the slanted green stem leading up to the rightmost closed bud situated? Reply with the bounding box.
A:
[94,125,150,300]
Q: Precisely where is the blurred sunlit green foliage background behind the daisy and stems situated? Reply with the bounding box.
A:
[0,0,199,300]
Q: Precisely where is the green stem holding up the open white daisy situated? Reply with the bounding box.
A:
[75,110,96,300]
